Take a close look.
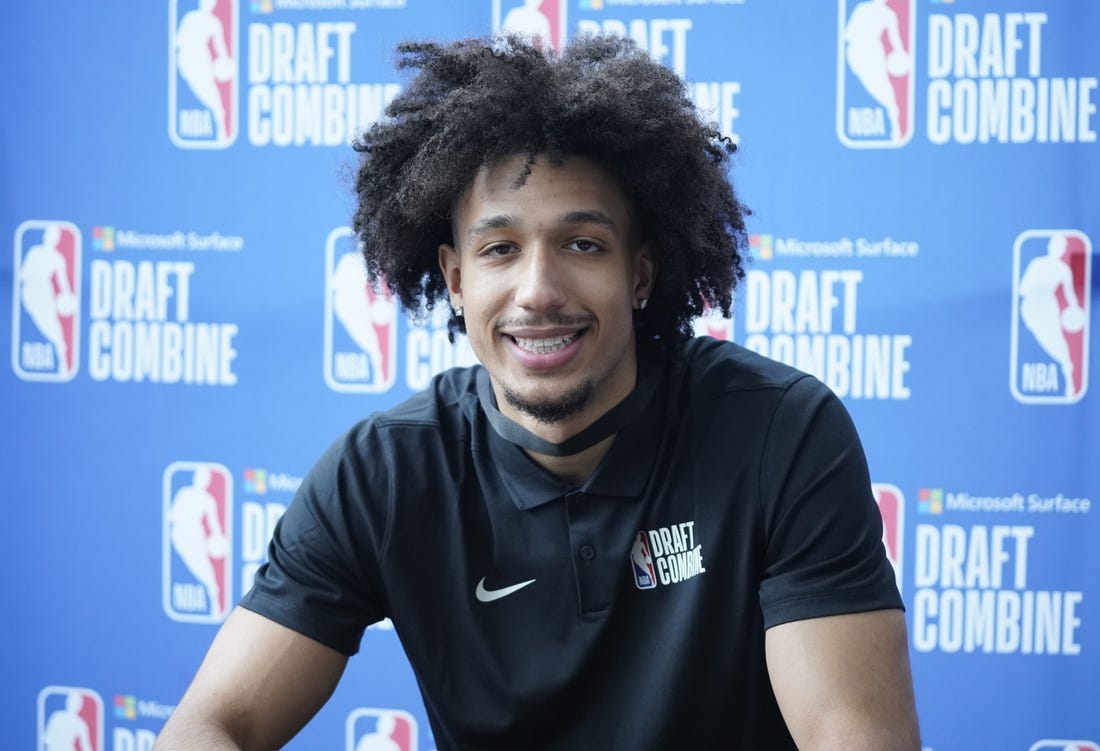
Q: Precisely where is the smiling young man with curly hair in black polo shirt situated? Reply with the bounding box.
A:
[156,33,920,751]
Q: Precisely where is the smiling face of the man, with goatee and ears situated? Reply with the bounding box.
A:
[439,156,653,440]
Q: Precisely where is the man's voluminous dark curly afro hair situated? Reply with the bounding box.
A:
[353,36,748,343]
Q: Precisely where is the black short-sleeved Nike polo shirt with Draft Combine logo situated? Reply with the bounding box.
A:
[242,338,901,750]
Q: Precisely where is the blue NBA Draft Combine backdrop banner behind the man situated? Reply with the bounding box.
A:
[0,0,1100,751]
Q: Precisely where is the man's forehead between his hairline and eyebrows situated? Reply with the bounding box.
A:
[454,155,634,233]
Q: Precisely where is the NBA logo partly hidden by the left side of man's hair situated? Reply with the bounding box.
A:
[325,228,397,394]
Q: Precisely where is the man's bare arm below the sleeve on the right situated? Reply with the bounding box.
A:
[766,609,921,751]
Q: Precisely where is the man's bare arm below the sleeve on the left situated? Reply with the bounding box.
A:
[153,607,348,751]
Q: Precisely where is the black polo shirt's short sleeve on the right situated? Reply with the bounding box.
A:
[759,376,902,628]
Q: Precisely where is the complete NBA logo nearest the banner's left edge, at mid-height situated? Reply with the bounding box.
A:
[11,220,80,382]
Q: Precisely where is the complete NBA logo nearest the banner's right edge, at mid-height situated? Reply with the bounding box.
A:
[1010,230,1092,405]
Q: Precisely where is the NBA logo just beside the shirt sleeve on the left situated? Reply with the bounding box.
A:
[162,462,233,623]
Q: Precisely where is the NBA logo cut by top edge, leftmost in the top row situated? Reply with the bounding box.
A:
[168,0,240,148]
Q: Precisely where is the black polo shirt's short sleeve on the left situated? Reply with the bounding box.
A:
[240,427,388,655]
